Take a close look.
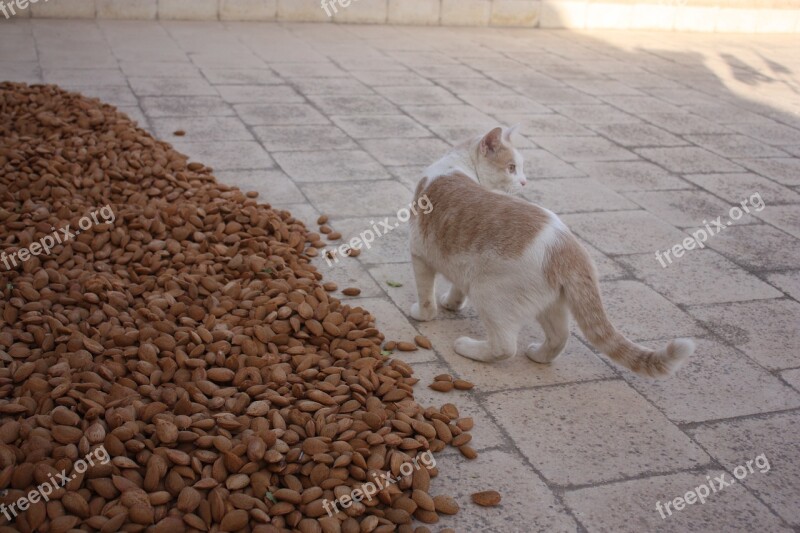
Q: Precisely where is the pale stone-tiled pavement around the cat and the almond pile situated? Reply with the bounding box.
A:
[0,20,800,533]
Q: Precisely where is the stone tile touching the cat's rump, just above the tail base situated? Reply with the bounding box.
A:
[562,211,686,254]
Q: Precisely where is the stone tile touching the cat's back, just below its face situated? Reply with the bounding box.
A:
[522,178,637,214]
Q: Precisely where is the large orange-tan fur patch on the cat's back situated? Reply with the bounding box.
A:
[414,173,563,259]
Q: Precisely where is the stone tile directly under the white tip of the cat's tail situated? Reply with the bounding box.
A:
[623,339,800,423]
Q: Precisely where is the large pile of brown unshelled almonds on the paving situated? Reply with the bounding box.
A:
[0,83,472,533]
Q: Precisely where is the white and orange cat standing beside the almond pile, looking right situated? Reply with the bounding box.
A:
[410,127,694,377]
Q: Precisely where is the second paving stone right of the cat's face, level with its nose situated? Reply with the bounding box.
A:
[575,161,692,191]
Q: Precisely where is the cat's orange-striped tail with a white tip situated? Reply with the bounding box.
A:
[550,235,695,377]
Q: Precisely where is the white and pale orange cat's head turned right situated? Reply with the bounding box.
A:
[475,126,528,193]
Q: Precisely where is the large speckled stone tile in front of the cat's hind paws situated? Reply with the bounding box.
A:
[486,380,709,486]
